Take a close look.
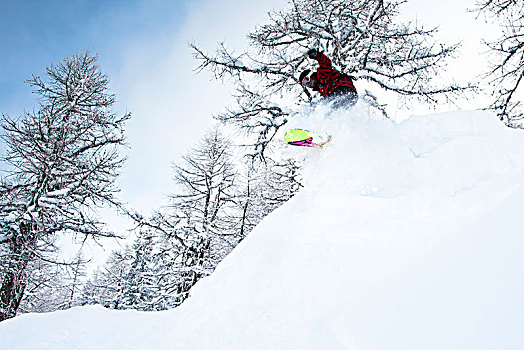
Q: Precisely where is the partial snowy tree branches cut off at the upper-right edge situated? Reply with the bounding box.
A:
[478,0,524,128]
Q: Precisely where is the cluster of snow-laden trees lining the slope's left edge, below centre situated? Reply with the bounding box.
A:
[81,129,302,311]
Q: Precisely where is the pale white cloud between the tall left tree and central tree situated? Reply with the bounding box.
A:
[103,0,284,219]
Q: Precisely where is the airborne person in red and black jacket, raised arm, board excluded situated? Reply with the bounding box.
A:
[299,49,357,106]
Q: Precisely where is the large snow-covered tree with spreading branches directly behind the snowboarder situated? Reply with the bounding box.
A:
[192,0,465,157]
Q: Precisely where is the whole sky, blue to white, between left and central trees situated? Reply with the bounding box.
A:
[0,0,282,249]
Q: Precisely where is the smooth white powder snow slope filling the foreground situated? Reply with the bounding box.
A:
[0,105,524,350]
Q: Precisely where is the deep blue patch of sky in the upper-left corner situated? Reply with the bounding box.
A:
[0,0,187,114]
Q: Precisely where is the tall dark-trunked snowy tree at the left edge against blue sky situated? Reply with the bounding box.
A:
[0,51,130,320]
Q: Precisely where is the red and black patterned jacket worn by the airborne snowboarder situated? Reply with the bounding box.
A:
[312,52,357,97]
